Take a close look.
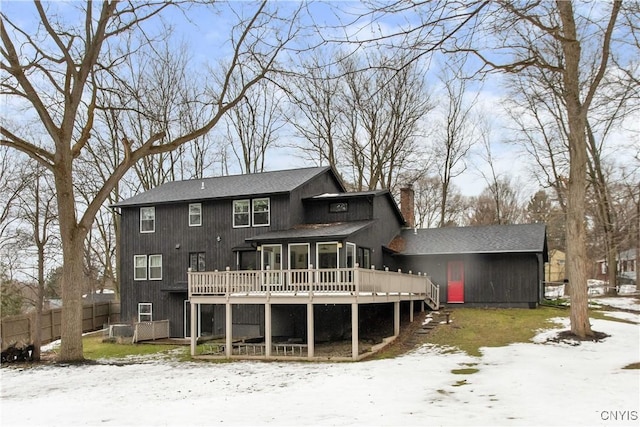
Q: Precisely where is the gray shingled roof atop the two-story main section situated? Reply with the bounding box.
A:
[112,166,344,207]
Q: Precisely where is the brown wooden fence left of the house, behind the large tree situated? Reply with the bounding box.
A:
[0,302,120,350]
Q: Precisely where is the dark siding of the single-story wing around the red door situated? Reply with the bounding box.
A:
[394,253,542,307]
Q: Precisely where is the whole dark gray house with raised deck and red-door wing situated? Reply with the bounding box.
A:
[114,167,547,359]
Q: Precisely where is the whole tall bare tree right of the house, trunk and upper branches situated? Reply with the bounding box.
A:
[455,1,622,337]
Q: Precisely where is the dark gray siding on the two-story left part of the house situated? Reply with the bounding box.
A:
[120,170,343,336]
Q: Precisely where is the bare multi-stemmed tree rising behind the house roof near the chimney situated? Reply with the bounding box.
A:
[340,55,433,191]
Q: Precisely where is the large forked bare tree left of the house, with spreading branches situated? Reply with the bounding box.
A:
[0,1,295,361]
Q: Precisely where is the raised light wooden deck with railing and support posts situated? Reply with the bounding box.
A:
[188,266,440,360]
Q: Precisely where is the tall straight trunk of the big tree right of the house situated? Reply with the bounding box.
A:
[557,1,593,338]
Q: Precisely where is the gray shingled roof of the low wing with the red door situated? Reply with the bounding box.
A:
[393,224,547,258]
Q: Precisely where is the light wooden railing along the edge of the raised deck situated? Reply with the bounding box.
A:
[188,267,439,301]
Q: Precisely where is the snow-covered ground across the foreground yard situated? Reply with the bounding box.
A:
[0,304,640,426]
